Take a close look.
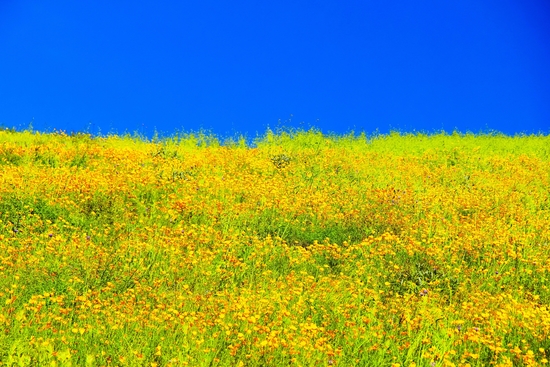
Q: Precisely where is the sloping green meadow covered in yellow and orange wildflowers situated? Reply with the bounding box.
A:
[0,130,550,367]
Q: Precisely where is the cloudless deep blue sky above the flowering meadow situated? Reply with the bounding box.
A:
[0,0,550,136]
